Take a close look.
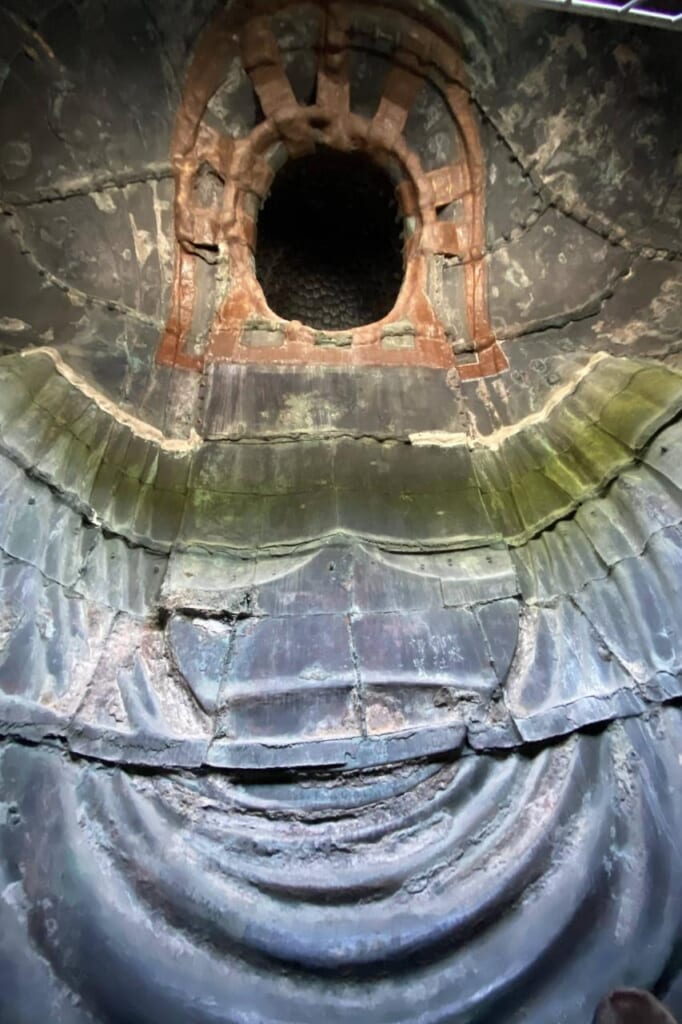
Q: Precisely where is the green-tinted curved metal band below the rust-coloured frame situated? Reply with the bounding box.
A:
[0,352,682,552]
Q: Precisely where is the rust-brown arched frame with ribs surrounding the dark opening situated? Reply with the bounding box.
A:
[158,0,507,379]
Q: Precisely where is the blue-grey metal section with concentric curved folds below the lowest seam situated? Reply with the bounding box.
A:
[2,710,682,1024]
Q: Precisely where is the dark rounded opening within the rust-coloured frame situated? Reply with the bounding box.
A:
[256,147,403,331]
